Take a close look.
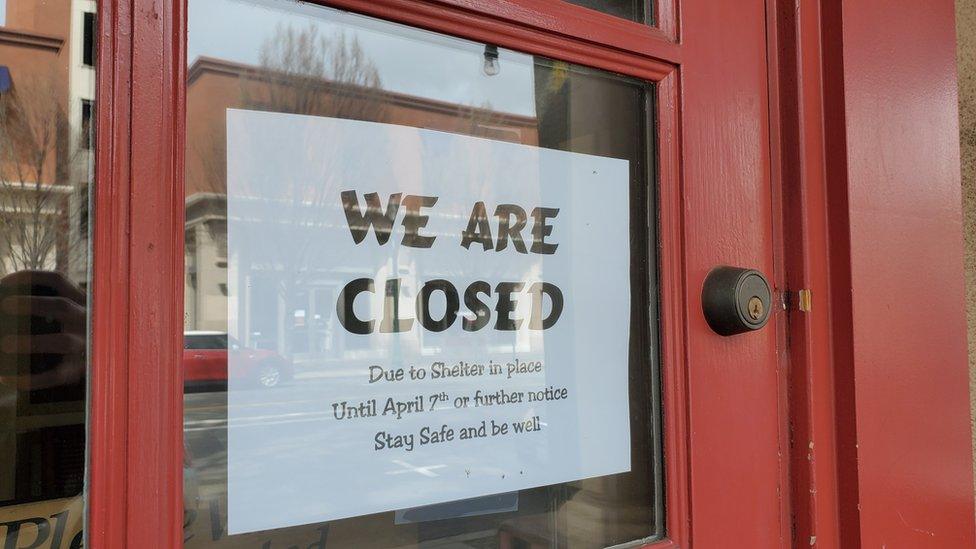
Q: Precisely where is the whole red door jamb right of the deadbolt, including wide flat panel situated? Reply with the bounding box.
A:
[770,0,976,548]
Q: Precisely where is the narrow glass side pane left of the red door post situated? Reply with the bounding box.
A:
[0,2,95,547]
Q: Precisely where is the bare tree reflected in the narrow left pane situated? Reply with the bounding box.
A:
[0,77,78,272]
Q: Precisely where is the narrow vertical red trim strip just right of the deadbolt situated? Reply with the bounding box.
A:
[770,0,857,548]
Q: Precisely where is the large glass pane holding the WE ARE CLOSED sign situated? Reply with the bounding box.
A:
[184,0,663,548]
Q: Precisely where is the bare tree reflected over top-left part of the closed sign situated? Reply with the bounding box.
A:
[241,25,385,352]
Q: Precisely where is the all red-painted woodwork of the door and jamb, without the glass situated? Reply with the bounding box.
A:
[88,0,973,548]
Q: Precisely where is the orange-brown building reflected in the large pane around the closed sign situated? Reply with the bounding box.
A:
[184,58,538,355]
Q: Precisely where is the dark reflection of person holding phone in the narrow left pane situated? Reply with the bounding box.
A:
[0,271,87,507]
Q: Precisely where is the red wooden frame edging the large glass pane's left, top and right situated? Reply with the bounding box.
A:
[86,0,690,549]
